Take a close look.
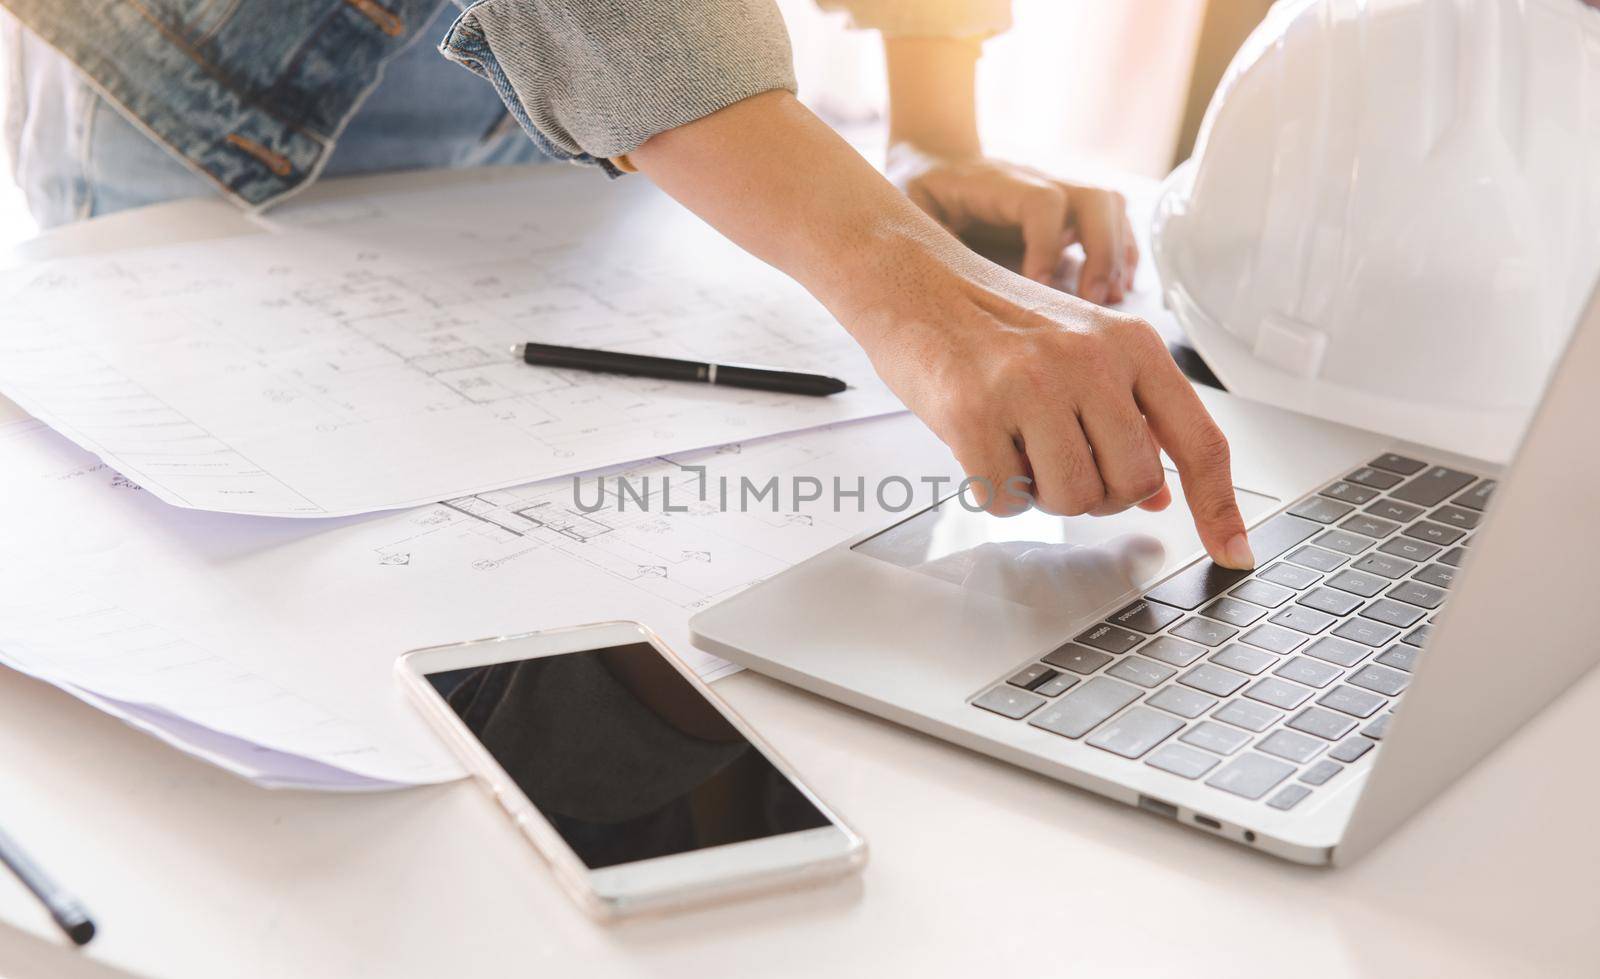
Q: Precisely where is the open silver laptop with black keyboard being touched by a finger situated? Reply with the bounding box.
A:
[691,275,1600,864]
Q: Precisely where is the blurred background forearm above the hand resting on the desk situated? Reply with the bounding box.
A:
[883,37,982,158]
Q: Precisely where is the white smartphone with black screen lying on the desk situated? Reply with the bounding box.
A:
[395,622,867,918]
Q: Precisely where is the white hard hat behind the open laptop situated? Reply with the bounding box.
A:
[1154,0,1600,461]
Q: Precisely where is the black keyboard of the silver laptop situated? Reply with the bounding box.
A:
[973,453,1494,809]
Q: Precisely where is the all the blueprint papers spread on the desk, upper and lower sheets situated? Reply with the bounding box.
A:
[0,170,955,789]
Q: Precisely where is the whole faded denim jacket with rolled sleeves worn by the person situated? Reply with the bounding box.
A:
[0,0,1006,206]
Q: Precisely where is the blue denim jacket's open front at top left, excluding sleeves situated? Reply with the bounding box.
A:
[5,0,464,206]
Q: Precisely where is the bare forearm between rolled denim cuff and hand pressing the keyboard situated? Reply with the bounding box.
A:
[630,91,976,341]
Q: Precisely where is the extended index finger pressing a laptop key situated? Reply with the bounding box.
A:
[1134,347,1256,569]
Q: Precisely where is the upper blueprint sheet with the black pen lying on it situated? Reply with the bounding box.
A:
[0,168,899,517]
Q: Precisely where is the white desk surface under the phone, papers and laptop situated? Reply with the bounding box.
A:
[0,167,1600,979]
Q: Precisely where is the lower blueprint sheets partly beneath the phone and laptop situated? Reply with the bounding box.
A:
[0,414,960,790]
